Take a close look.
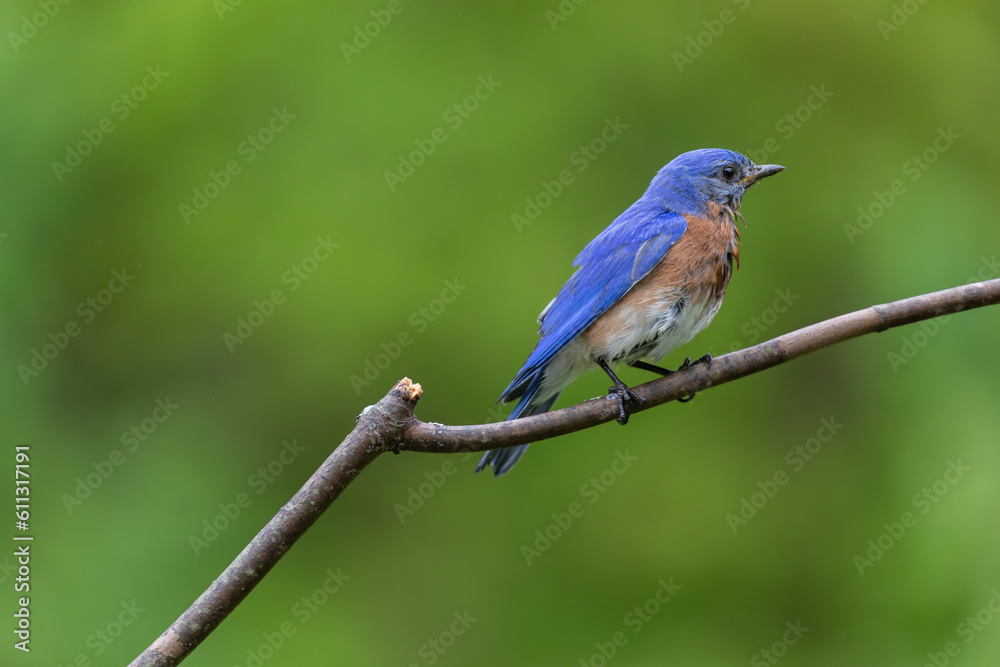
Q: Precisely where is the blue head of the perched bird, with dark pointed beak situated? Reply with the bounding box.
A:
[646,148,784,219]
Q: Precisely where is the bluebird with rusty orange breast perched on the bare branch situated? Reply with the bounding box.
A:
[476,148,784,476]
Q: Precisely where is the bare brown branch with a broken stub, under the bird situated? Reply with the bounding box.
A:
[131,279,1000,667]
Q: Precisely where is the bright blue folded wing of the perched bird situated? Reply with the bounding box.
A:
[500,199,687,402]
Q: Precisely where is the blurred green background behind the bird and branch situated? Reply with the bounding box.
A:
[0,0,1000,667]
